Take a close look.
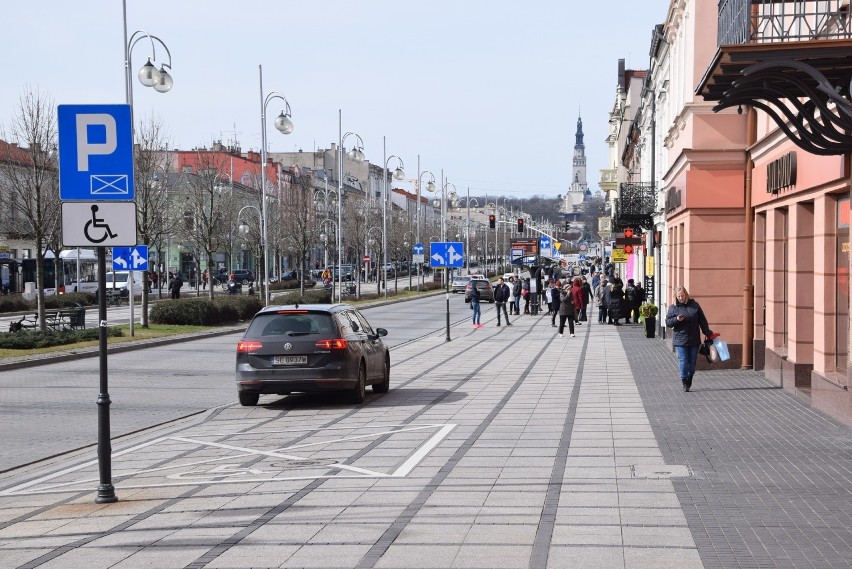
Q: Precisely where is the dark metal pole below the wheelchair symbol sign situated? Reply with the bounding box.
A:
[95,247,118,504]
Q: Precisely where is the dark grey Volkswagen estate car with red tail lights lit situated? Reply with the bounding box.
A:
[236,304,390,406]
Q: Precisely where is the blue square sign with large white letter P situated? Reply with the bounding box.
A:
[58,105,136,201]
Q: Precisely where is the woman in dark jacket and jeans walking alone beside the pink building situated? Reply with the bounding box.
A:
[666,286,716,392]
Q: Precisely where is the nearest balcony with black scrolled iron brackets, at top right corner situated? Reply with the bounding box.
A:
[696,0,852,155]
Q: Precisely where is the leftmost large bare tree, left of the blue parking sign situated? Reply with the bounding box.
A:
[0,89,60,330]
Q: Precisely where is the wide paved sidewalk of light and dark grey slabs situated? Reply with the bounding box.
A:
[0,308,852,569]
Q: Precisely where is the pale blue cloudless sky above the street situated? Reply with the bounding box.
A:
[0,0,669,197]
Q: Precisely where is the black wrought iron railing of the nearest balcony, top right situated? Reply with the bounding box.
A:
[718,0,852,46]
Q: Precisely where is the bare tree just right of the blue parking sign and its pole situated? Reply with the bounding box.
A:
[134,119,172,322]
